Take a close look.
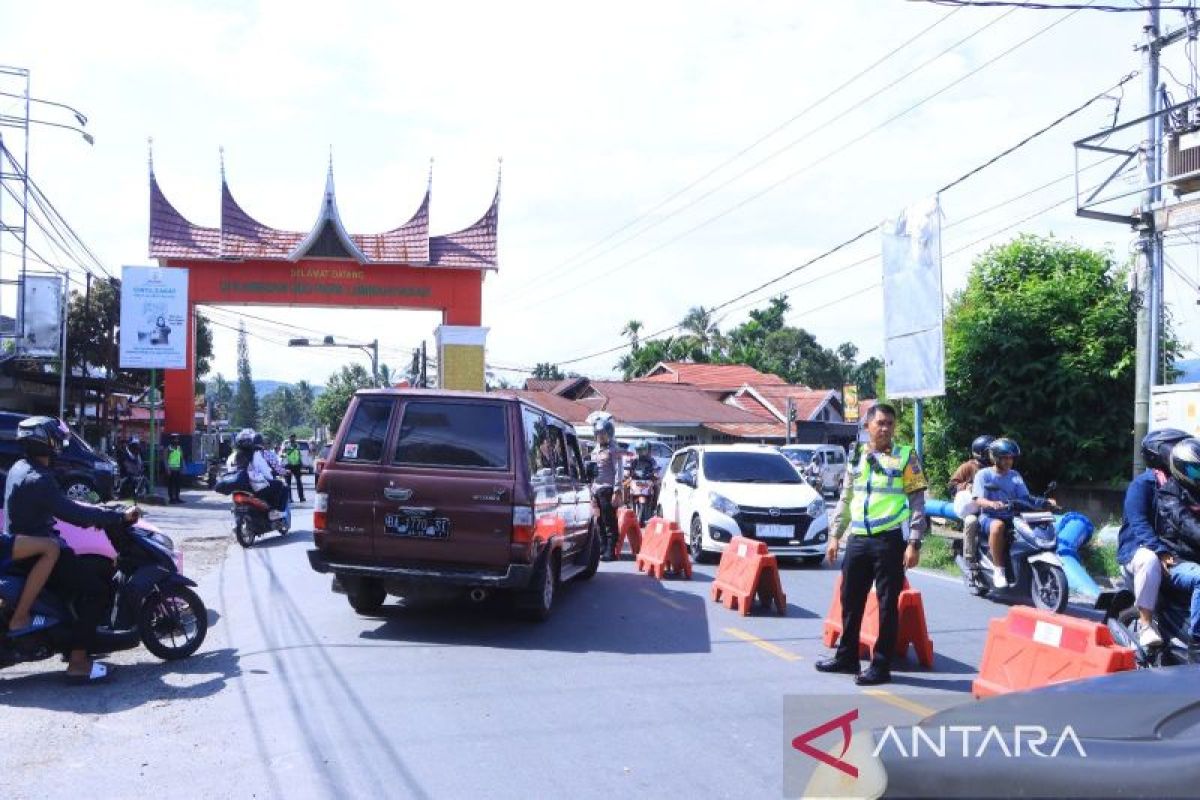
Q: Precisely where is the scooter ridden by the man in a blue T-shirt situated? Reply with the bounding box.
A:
[954,483,1070,614]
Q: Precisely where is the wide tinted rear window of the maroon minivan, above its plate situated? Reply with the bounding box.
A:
[394,401,509,469]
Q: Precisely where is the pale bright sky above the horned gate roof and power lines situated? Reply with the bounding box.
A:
[0,0,1185,381]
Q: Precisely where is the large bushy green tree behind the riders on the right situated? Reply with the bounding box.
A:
[925,235,1180,488]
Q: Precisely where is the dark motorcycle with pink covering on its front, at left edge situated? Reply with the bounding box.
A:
[0,505,209,668]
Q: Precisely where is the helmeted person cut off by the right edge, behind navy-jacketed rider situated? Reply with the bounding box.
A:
[1156,438,1200,663]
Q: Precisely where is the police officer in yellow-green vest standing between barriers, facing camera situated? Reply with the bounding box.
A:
[816,403,929,686]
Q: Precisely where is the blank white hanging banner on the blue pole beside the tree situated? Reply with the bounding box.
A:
[880,197,946,398]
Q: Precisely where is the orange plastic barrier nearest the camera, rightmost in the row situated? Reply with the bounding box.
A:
[971,606,1135,697]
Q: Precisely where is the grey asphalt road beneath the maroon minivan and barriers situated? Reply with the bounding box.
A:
[0,484,1032,798]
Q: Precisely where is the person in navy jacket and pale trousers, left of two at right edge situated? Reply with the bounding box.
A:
[1117,428,1188,648]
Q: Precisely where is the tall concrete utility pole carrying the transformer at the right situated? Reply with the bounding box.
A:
[1133,6,1163,475]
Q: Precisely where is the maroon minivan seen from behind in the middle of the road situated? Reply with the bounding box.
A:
[308,389,600,619]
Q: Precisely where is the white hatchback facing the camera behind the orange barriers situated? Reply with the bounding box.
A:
[659,445,829,564]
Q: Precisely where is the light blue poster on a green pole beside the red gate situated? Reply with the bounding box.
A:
[121,266,187,369]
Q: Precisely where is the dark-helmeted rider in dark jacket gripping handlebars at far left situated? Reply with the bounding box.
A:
[5,416,139,682]
